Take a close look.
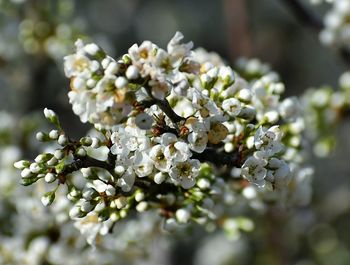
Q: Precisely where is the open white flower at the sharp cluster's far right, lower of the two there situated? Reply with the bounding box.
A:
[241,156,267,186]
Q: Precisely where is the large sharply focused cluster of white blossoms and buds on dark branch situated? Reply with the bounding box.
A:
[15,32,310,244]
